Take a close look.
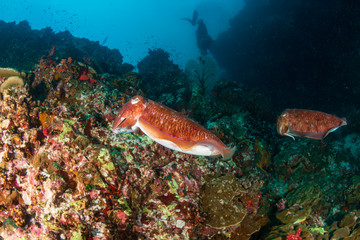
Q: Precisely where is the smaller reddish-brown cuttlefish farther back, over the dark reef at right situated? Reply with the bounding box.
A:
[276,109,347,140]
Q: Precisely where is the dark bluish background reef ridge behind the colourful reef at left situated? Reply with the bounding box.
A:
[0,21,134,75]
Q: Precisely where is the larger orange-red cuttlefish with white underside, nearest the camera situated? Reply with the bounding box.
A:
[112,96,236,159]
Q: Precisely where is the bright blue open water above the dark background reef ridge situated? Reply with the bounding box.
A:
[0,0,244,66]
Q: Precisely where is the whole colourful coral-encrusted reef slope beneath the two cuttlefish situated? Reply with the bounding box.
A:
[0,32,360,240]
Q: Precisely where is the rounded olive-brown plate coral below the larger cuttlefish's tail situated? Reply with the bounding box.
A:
[200,174,267,239]
